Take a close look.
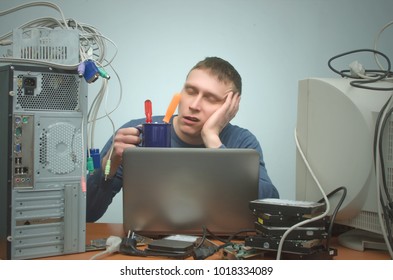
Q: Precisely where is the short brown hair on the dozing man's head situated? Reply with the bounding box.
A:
[190,57,242,95]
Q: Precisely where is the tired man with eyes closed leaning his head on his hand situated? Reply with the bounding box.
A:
[86,57,279,222]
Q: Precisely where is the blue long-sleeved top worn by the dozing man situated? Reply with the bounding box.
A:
[86,116,279,222]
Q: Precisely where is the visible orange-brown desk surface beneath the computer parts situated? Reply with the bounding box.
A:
[41,223,390,260]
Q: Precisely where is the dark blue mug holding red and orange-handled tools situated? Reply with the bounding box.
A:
[138,123,172,148]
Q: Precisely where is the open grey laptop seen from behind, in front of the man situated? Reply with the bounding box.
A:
[123,148,259,237]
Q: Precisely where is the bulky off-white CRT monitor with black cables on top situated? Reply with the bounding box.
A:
[296,78,393,252]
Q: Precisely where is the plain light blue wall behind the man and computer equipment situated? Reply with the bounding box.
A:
[0,0,393,222]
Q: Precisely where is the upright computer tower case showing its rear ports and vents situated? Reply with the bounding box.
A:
[0,65,87,259]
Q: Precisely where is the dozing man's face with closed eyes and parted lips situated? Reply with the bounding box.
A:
[175,69,233,145]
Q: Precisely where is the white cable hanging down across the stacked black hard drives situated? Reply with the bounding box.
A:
[276,128,330,260]
